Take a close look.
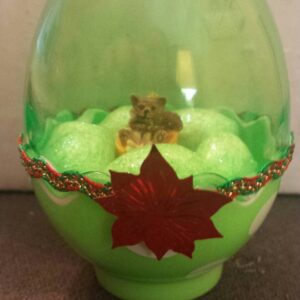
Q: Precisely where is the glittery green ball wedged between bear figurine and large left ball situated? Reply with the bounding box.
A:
[101,106,132,137]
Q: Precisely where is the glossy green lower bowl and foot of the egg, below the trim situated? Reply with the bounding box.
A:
[33,179,280,300]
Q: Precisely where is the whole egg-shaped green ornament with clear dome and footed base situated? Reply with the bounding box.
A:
[20,0,293,300]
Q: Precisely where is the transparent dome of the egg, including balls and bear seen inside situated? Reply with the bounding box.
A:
[25,0,290,179]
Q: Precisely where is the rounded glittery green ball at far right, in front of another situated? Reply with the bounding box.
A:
[196,133,257,179]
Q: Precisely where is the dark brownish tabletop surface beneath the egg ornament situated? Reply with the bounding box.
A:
[0,192,300,300]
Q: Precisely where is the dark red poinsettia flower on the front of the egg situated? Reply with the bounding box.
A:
[98,146,231,259]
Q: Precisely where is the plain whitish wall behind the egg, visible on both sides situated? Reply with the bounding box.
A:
[0,0,300,193]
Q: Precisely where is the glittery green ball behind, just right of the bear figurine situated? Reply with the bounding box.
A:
[176,108,239,151]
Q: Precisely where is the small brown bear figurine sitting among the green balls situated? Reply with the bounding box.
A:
[116,95,183,153]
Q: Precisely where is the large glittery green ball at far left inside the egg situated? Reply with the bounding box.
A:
[40,121,115,172]
